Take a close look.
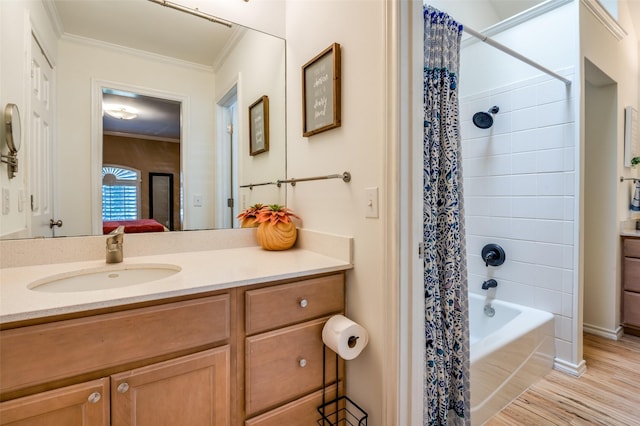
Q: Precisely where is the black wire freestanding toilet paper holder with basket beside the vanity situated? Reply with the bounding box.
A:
[317,344,369,426]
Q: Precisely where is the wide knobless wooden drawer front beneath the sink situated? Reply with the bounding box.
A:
[0,294,230,393]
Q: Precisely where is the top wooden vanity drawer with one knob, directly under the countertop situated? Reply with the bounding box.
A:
[245,274,344,335]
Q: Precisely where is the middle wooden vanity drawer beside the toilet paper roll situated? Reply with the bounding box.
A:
[245,318,343,415]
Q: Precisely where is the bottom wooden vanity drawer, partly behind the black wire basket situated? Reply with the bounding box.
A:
[244,382,342,426]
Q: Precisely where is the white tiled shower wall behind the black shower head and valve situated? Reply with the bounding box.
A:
[461,70,577,372]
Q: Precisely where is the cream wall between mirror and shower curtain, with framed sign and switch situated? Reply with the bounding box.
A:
[286,0,393,426]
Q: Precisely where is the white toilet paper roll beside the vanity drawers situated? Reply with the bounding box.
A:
[322,315,369,360]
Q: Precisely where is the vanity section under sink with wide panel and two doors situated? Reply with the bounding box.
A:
[0,291,235,426]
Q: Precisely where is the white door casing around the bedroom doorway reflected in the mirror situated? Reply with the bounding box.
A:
[91,79,190,235]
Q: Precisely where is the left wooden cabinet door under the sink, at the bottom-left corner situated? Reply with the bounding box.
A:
[0,378,109,426]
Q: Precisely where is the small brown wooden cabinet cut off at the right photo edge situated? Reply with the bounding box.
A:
[622,237,640,334]
